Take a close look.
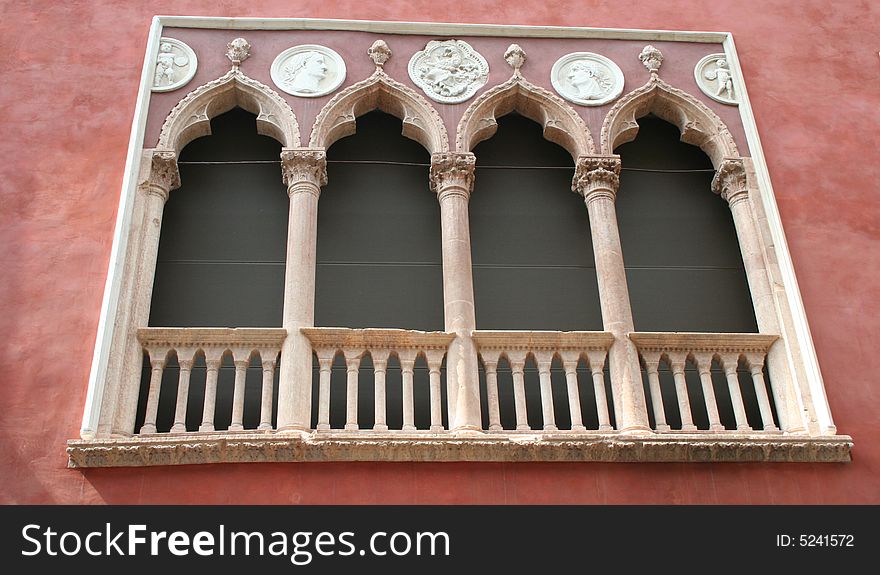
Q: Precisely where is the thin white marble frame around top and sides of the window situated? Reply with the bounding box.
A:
[81,16,836,450]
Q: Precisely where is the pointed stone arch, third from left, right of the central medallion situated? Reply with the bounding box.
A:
[455,73,595,160]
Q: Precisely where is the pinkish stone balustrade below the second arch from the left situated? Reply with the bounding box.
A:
[300,327,455,432]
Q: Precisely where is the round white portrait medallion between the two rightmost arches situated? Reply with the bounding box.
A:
[550,52,623,106]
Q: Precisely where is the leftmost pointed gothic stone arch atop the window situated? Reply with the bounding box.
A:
[156,68,300,154]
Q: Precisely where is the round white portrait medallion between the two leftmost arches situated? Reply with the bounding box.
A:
[271,44,345,98]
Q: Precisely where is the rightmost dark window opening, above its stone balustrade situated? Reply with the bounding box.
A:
[616,116,758,333]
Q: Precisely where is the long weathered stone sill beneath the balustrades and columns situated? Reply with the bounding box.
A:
[67,431,853,468]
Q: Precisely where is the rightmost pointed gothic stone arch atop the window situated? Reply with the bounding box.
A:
[601,74,739,169]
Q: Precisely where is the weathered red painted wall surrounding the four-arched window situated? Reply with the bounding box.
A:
[0,0,880,504]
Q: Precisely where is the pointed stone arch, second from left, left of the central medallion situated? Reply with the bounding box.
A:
[309,65,449,154]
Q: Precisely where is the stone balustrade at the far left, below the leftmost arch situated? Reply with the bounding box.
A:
[137,328,287,435]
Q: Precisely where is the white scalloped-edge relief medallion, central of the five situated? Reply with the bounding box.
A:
[409,40,489,104]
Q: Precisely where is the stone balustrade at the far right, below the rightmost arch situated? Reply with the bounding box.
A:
[629,332,780,433]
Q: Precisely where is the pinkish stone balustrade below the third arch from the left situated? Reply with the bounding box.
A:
[473,330,614,432]
